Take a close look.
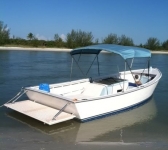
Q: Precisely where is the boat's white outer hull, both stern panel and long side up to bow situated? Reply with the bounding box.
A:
[26,69,162,121]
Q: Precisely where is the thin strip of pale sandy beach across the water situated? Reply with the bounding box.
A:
[0,46,168,54]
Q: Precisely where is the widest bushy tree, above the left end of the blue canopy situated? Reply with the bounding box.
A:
[66,30,93,48]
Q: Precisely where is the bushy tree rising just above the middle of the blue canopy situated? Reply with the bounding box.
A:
[102,33,119,44]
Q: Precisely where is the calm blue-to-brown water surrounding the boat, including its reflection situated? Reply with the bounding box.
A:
[0,50,168,150]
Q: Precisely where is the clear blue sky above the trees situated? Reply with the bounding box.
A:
[0,0,168,45]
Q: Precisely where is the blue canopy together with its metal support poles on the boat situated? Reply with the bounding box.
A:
[70,44,151,86]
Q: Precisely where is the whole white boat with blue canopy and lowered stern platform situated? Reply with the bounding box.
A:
[5,44,162,125]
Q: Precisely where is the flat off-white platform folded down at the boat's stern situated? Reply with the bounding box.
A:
[5,100,75,125]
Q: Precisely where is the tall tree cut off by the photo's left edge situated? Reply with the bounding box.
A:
[0,21,10,45]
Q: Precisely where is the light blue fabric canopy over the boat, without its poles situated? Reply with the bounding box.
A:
[70,44,151,59]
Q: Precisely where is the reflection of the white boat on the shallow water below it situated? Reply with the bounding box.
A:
[7,98,157,142]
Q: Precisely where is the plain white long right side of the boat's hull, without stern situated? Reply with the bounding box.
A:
[76,79,157,121]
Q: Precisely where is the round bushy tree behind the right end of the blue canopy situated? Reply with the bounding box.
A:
[145,37,160,50]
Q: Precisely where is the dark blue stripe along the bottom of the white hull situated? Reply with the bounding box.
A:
[76,95,152,122]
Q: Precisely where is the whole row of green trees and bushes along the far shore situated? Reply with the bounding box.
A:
[0,21,168,50]
